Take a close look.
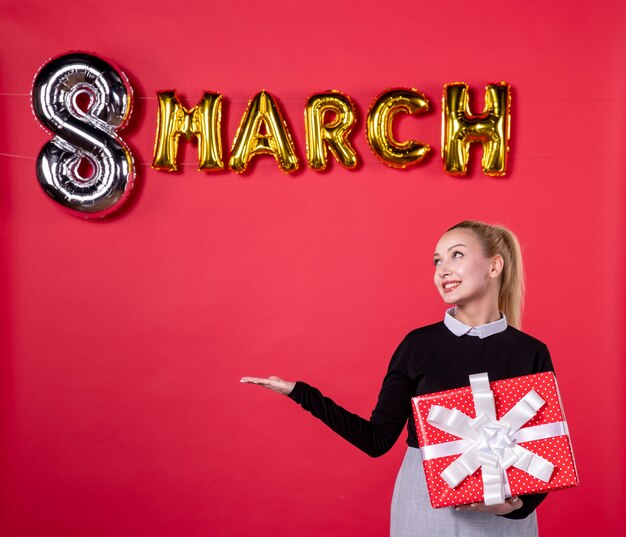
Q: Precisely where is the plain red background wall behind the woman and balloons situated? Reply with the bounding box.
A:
[0,0,626,537]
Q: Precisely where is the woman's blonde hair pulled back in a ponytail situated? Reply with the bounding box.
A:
[448,220,525,329]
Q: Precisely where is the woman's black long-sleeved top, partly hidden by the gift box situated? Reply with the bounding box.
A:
[289,322,554,519]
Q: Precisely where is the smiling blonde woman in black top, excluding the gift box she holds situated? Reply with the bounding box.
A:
[241,221,553,537]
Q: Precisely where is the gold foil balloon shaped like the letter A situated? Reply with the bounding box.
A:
[229,91,299,173]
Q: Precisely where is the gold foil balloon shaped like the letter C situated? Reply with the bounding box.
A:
[367,88,430,169]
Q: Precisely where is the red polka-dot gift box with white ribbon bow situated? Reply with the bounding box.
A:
[412,372,578,508]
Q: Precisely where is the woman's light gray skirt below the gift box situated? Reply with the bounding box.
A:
[391,447,538,537]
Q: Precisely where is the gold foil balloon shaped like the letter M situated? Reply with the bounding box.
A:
[152,91,224,171]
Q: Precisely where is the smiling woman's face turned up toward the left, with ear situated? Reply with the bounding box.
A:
[434,229,502,306]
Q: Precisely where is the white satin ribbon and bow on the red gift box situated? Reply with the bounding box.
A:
[423,373,552,505]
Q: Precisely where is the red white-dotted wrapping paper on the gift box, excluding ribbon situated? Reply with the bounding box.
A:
[412,372,578,508]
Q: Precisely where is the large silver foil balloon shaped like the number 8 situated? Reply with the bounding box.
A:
[32,53,135,218]
